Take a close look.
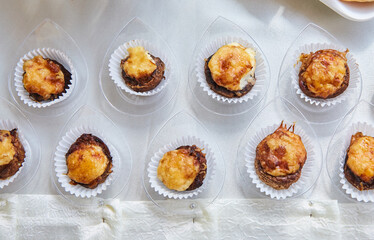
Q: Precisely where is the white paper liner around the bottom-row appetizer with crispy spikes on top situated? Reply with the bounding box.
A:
[244,123,316,199]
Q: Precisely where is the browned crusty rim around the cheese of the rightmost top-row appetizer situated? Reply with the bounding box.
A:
[299,49,350,99]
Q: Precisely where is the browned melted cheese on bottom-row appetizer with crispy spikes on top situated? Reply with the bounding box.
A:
[260,126,306,177]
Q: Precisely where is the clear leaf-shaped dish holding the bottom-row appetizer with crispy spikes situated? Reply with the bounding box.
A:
[236,97,323,199]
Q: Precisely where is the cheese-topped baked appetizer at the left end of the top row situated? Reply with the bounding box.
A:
[23,55,71,102]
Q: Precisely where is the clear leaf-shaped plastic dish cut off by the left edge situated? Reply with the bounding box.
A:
[0,97,41,193]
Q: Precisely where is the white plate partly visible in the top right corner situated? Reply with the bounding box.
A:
[320,0,374,22]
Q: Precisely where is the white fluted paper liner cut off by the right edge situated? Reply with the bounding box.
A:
[339,122,374,202]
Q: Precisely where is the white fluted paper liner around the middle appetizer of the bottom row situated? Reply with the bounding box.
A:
[147,136,216,199]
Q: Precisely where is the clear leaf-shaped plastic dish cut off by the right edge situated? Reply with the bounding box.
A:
[325,100,374,202]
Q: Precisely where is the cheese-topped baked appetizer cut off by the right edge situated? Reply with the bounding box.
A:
[344,132,374,191]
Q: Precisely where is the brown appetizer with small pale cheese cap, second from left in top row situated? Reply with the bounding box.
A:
[121,46,165,92]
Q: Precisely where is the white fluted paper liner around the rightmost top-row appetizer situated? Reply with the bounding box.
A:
[291,43,360,107]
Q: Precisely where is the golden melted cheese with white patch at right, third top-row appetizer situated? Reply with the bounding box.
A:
[208,43,256,91]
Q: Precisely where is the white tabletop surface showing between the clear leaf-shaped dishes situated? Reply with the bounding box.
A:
[0,0,374,201]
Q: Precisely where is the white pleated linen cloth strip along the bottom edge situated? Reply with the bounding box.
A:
[0,195,374,240]
